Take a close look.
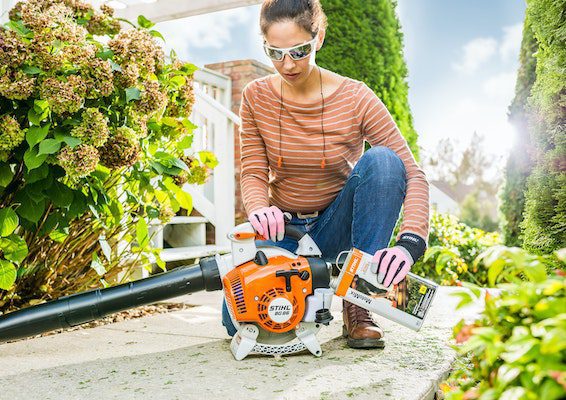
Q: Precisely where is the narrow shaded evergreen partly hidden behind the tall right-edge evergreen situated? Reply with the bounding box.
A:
[500,17,538,246]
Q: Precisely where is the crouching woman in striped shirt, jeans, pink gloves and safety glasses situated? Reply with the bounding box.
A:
[223,0,429,348]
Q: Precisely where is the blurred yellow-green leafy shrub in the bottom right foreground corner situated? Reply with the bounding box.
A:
[441,247,566,400]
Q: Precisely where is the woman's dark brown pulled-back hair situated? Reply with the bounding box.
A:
[259,0,327,37]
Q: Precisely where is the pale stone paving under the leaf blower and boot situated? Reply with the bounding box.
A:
[0,287,483,400]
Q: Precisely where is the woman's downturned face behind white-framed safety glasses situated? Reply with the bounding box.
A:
[264,21,324,86]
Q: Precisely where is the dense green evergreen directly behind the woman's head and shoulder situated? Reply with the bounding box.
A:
[317,0,418,159]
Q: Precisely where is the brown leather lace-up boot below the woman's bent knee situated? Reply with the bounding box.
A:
[342,300,385,349]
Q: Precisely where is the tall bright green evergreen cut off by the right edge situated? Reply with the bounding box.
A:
[521,0,566,253]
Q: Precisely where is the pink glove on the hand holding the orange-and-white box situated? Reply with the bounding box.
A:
[371,246,414,287]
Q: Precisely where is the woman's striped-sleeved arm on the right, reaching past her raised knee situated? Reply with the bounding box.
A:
[356,84,430,242]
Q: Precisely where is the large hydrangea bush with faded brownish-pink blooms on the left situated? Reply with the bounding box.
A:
[0,0,217,309]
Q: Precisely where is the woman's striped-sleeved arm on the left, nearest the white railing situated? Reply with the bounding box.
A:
[240,85,269,215]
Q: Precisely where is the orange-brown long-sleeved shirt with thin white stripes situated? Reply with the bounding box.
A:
[240,76,429,241]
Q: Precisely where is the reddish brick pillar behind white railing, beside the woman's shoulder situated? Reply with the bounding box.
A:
[205,60,275,224]
